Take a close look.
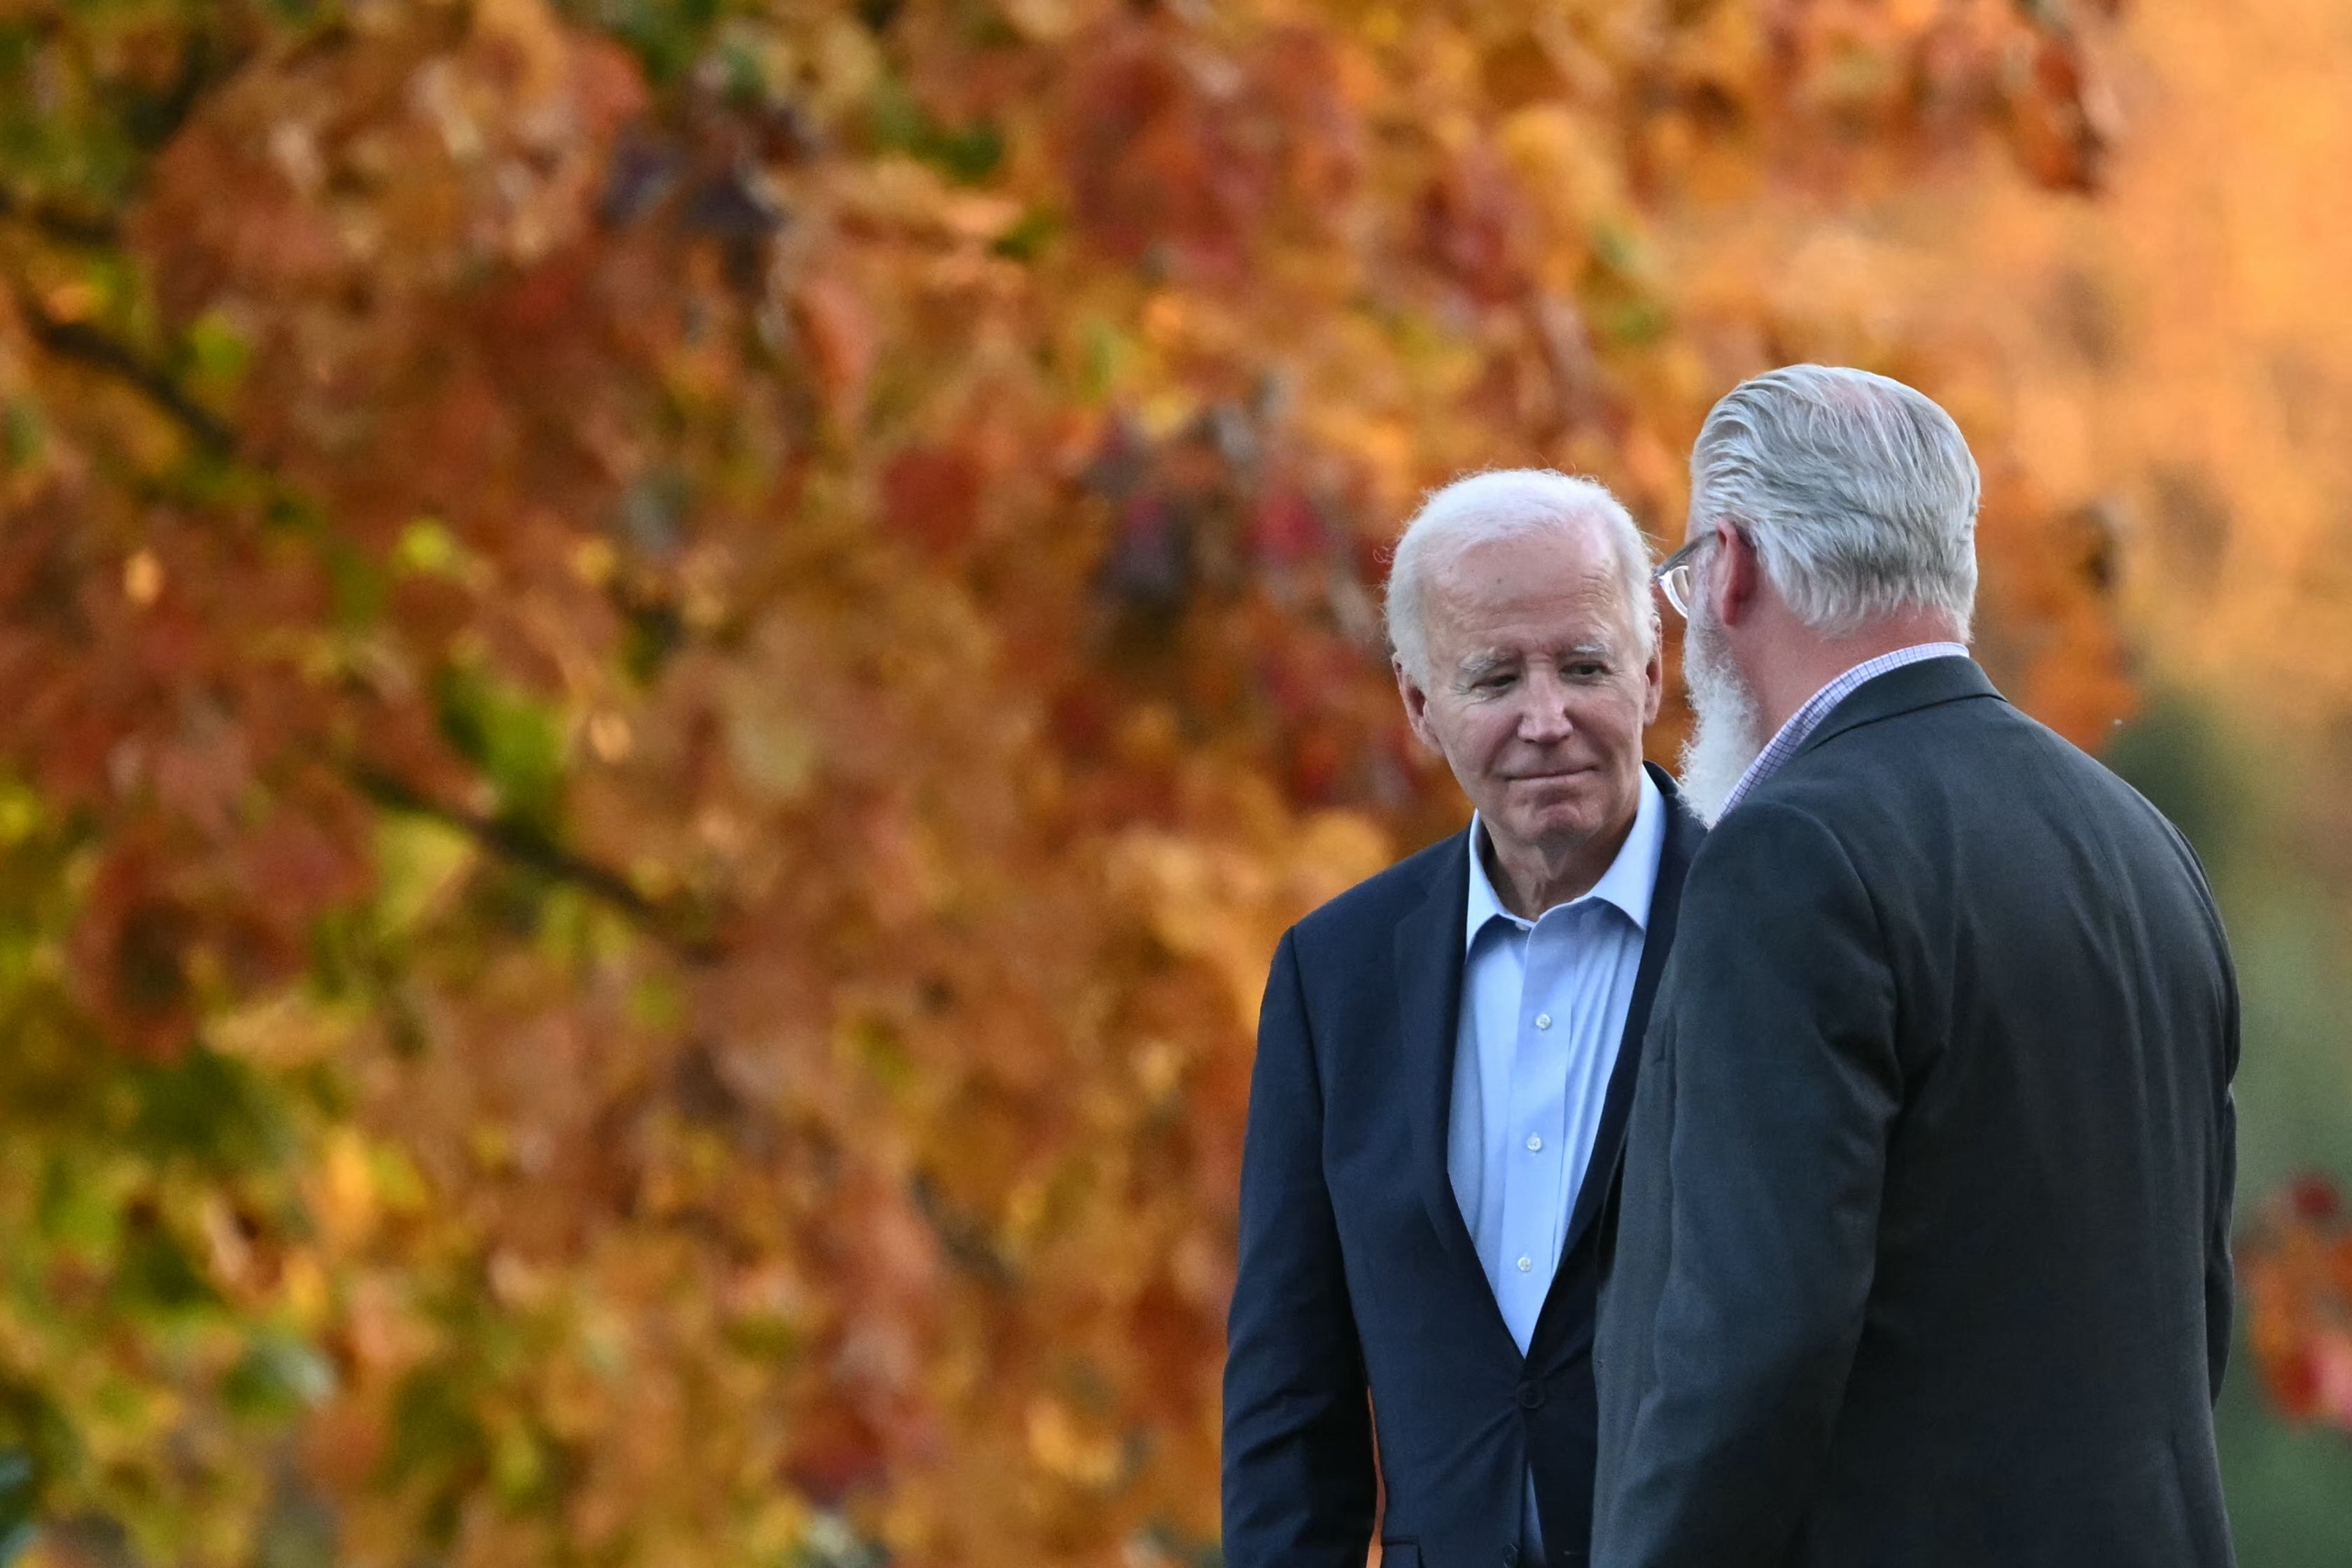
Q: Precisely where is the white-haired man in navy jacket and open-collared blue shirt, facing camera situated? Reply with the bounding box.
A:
[1223,470,1703,1568]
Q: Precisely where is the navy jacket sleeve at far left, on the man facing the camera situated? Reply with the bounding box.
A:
[1223,936,1376,1568]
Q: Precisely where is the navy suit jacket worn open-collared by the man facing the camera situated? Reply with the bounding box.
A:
[1223,769,1705,1568]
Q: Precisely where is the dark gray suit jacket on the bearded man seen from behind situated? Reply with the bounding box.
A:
[1592,658,2236,1568]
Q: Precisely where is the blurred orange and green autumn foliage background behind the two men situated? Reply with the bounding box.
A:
[0,0,2352,1568]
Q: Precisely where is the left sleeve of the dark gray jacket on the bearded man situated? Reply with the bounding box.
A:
[1592,802,1903,1568]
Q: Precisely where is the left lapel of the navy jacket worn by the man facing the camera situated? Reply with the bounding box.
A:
[1397,832,1487,1291]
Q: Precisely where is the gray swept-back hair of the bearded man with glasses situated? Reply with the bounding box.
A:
[1691,365,1982,637]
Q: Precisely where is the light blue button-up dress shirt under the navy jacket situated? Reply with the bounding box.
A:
[1446,771,1665,1563]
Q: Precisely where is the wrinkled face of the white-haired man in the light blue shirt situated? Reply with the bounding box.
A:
[1397,524,1660,869]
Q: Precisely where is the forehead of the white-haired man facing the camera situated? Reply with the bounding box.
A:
[1428,522,1630,658]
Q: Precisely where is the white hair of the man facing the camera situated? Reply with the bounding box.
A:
[1387,468,1658,687]
